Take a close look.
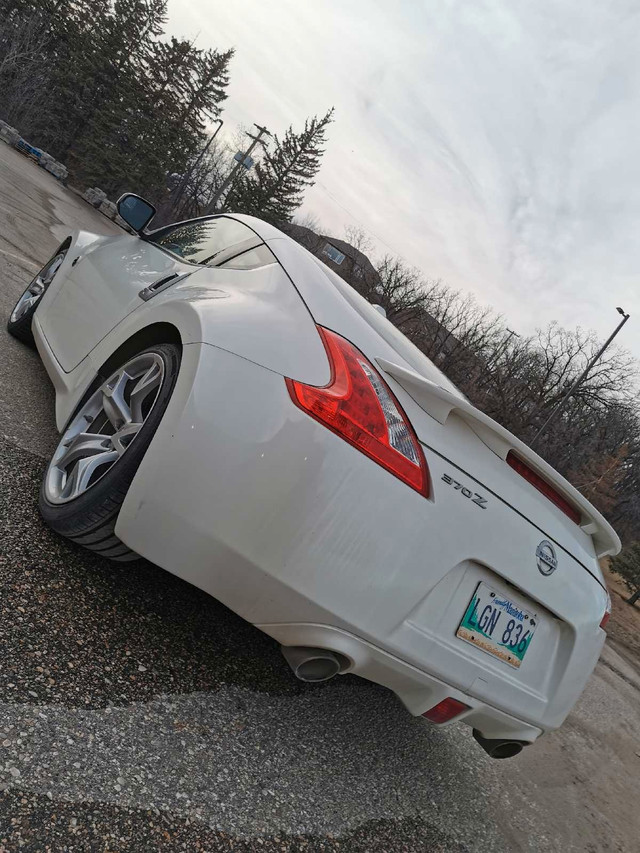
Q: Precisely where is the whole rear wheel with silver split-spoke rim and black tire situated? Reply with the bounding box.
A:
[40,344,180,562]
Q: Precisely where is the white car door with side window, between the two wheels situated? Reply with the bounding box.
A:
[43,216,261,371]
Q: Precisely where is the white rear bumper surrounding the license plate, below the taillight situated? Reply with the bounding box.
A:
[116,344,606,741]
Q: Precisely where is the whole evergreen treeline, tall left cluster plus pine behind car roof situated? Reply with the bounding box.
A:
[0,0,333,221]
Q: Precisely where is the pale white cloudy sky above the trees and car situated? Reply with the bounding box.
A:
[169,0,640,357]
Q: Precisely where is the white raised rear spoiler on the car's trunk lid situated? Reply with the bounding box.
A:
[376,358,622,557]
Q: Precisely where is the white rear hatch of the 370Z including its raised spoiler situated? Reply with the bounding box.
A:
[268,238,621,572]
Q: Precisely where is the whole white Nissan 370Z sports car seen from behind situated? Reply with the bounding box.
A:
[9,194,620,758]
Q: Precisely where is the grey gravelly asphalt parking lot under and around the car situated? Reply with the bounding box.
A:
[0,143,640,853]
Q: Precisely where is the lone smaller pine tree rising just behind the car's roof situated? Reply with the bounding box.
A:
[224,108,333,223]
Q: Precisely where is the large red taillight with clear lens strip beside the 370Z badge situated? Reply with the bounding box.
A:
[287,326,429,497]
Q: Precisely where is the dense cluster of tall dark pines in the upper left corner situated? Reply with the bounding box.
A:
[0,0,233,201]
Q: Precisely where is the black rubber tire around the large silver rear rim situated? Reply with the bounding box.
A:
[40,344,181,562]
